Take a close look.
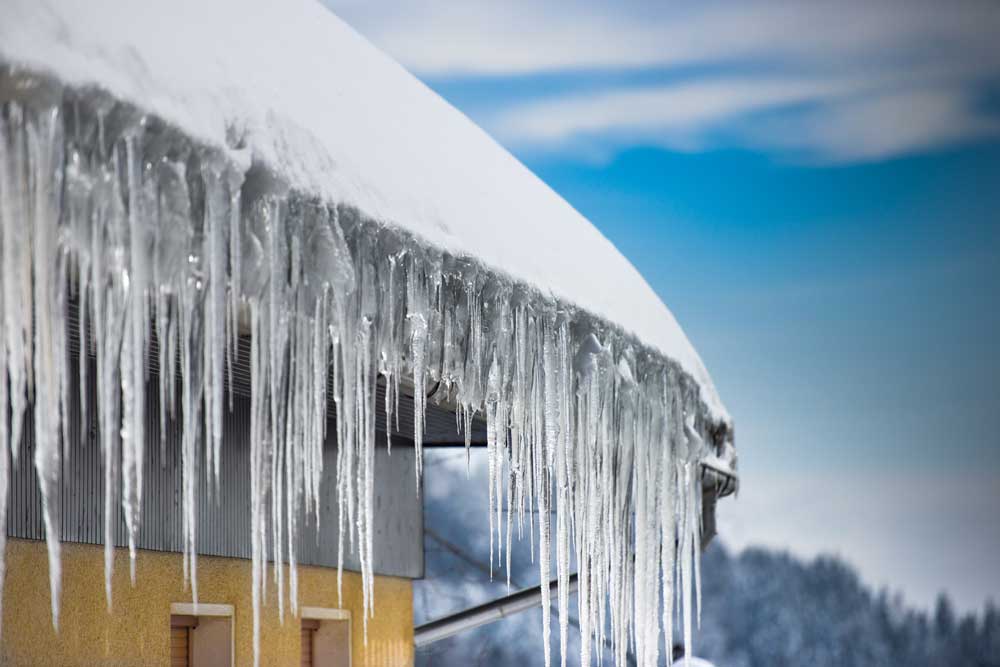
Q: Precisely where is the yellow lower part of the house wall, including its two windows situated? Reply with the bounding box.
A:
[0,539,413,667]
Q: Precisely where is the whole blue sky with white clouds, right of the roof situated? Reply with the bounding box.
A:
[327,0,1000,609]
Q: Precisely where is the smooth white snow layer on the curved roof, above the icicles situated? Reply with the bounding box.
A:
[0,0,729,422]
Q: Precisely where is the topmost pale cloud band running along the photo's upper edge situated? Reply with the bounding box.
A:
[326,0,1000,76]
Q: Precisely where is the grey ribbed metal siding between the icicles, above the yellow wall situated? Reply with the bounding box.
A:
[7,354,423,578]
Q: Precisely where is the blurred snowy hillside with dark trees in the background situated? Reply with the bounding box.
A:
[414,452,1000,667]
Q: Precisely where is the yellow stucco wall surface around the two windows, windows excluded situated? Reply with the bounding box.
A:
[0,539,413,667]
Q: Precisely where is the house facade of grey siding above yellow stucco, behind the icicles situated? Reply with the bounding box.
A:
[0,349,423,667]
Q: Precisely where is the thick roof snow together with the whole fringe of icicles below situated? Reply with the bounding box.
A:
[0,0,734,665]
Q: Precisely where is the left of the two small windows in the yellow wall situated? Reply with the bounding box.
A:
[170,602,233,667]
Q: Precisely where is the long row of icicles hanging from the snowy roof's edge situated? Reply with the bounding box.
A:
[0,75,728,665]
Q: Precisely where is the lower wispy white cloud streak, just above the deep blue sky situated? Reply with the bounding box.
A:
[484,78,1000,162]
